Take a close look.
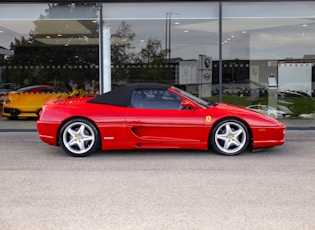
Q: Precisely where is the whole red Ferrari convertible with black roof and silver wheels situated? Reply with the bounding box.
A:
[37,83,286,156]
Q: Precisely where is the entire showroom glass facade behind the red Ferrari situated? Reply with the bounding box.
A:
[0,1,315,127]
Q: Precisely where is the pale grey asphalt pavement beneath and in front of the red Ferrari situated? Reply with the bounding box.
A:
[0,130,315,230]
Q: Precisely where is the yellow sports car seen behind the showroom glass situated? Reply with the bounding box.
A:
[2,85,69,119]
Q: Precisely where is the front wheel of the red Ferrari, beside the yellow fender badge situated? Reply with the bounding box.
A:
[210,119,251,156]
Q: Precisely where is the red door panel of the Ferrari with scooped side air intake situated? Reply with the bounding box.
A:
[126,108,204,144]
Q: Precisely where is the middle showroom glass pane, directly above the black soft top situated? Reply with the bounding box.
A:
[103,2,219,97]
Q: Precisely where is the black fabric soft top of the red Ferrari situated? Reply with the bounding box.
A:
[88,83,171,107]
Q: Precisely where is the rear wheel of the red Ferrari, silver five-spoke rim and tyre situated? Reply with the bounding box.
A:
[59,119,99,157]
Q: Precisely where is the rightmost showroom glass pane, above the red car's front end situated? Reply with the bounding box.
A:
[222,1,315,126]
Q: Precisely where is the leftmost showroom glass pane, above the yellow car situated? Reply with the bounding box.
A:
[0,3,99,97]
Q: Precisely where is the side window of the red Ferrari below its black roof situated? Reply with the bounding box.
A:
[131,89,182,110]
